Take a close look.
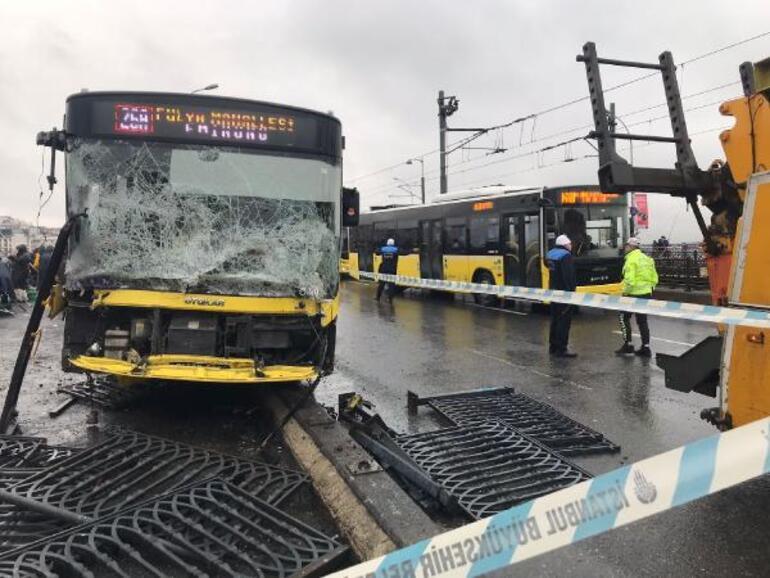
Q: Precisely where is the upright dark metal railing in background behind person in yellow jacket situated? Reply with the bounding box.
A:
[642,243,709,291]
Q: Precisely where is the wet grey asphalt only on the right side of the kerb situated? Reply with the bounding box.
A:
[316,281,770,577]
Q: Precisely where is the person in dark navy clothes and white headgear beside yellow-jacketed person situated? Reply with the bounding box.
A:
[546,235,577,357]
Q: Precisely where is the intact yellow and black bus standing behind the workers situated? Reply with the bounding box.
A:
[350,185,629,302]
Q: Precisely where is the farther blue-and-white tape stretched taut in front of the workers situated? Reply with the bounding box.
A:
[359,271,770,328]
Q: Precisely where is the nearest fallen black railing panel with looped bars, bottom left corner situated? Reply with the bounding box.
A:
[0,480,345,578]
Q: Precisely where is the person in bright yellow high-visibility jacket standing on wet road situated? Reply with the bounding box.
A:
[615,237,658,357]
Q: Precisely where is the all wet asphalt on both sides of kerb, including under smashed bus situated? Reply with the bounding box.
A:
[0,281,770,577]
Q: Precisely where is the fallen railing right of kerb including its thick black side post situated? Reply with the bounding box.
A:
[339,394,590,519]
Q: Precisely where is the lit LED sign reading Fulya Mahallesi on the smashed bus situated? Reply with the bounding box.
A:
[112,103,297,144]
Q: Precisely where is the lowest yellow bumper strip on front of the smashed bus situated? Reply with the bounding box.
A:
[69,355,318,383]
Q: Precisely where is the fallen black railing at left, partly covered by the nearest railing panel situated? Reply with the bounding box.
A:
[0,429,307,550]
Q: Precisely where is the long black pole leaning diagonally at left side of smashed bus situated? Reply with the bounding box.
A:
[0,213,86,433]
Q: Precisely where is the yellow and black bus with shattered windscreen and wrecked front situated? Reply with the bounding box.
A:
[48,92,358,383]
